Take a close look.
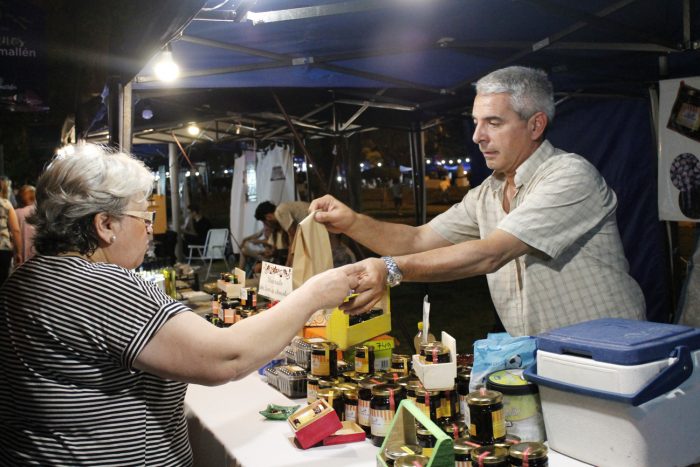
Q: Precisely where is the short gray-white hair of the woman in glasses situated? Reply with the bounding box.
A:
[29,143,153,255]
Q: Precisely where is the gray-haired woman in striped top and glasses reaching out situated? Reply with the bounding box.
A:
[0,145,358,466]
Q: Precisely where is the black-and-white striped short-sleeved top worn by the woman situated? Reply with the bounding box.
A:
[0,256,192,466]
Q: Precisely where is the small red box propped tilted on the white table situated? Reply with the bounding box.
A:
[287,399,343,449]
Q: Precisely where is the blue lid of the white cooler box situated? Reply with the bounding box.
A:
[537,318,700,365]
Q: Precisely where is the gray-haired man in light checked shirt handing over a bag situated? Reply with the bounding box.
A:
[310,67,645,335]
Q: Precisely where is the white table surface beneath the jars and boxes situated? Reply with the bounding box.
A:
[185,373,587,467]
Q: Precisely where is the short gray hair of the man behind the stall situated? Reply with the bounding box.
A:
[476,66,554,122]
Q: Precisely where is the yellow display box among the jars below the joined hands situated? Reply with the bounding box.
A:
[326,287,391,350]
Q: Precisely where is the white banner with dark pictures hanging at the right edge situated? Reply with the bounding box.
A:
[658,77,700,222]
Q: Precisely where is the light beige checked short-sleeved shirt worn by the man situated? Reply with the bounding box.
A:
[429,141,645,335]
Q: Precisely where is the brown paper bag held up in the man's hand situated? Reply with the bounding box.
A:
[292,213,333,326]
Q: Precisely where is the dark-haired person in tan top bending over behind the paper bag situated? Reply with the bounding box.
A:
[255,201,309,266]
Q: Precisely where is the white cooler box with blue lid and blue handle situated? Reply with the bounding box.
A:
[525,319,700,467]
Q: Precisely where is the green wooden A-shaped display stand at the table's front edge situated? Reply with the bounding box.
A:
[377,400,455,467]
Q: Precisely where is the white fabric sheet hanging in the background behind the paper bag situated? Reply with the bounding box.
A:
[229,146,295,253]
